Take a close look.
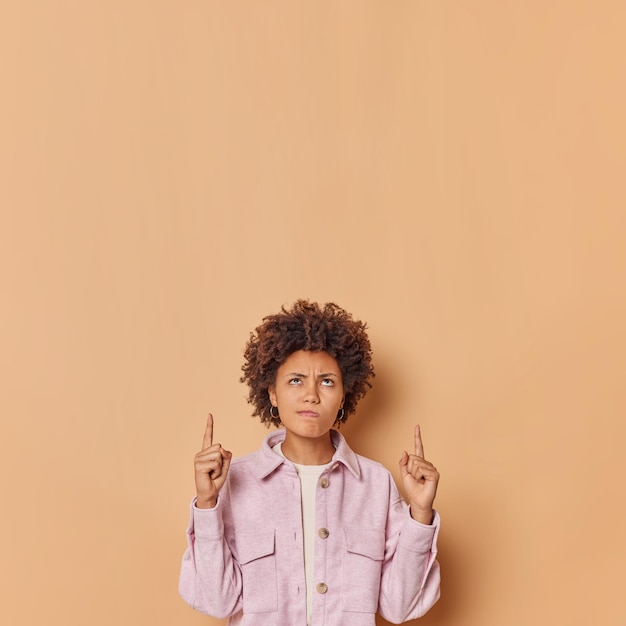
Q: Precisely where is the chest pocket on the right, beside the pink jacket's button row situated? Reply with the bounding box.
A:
[342,528,385,613]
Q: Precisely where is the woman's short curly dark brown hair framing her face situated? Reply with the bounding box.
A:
[240,300,374,428]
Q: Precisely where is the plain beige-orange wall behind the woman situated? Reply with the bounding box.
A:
[0,0,626,626]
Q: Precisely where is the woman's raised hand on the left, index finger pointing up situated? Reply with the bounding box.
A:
[194,413,233,509]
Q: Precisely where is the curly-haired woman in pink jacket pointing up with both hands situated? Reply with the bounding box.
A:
[180,300,439,626]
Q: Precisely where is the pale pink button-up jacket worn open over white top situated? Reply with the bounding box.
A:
[179,430,439,626]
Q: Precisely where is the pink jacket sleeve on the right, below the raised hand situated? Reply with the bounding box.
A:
[378,476,440,624]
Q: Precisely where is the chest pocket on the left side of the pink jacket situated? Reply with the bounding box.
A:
[237,530,278,613]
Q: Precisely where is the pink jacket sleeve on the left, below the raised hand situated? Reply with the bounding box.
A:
[178,494,242,618]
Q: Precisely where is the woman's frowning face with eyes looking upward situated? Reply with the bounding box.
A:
[269,350,344,438]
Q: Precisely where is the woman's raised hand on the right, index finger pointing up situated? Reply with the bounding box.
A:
[400,424,439,524]
